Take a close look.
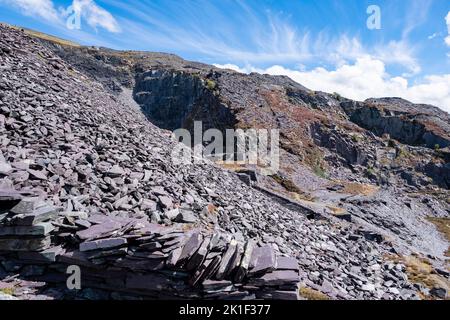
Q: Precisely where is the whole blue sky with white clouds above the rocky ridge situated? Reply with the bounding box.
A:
[0,0,450,111]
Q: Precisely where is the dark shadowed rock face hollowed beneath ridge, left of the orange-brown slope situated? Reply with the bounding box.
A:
[133,70,235,132]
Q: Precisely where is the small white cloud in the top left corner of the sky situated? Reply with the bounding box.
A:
[0,0,59,22]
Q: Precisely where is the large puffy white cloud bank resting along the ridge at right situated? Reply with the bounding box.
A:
[216,56,450,112]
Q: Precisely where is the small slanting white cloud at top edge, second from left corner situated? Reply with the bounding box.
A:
[72,0,121,32]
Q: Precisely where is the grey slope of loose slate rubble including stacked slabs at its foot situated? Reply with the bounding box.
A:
[0,25,448,299]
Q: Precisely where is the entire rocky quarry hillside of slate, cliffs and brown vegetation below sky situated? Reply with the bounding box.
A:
[0,25,450,299]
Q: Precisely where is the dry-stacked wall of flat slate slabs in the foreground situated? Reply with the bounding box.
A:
[0,191,299,299]
